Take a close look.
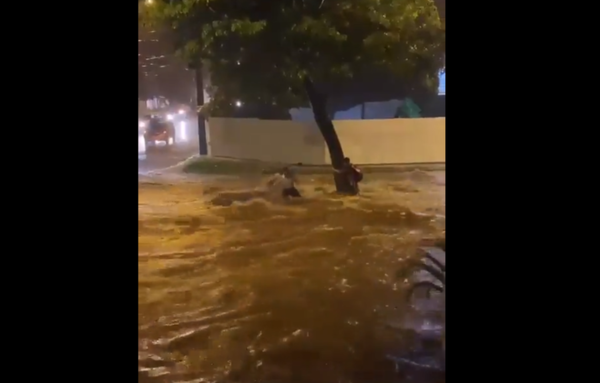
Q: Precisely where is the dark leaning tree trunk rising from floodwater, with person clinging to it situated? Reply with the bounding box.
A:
[304,77,356,195]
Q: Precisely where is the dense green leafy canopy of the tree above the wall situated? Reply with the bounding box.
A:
[140,0,445,113]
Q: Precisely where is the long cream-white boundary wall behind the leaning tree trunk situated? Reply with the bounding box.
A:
[208,118,446,165]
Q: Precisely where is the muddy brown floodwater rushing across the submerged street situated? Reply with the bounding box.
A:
[139,171,445,383]
